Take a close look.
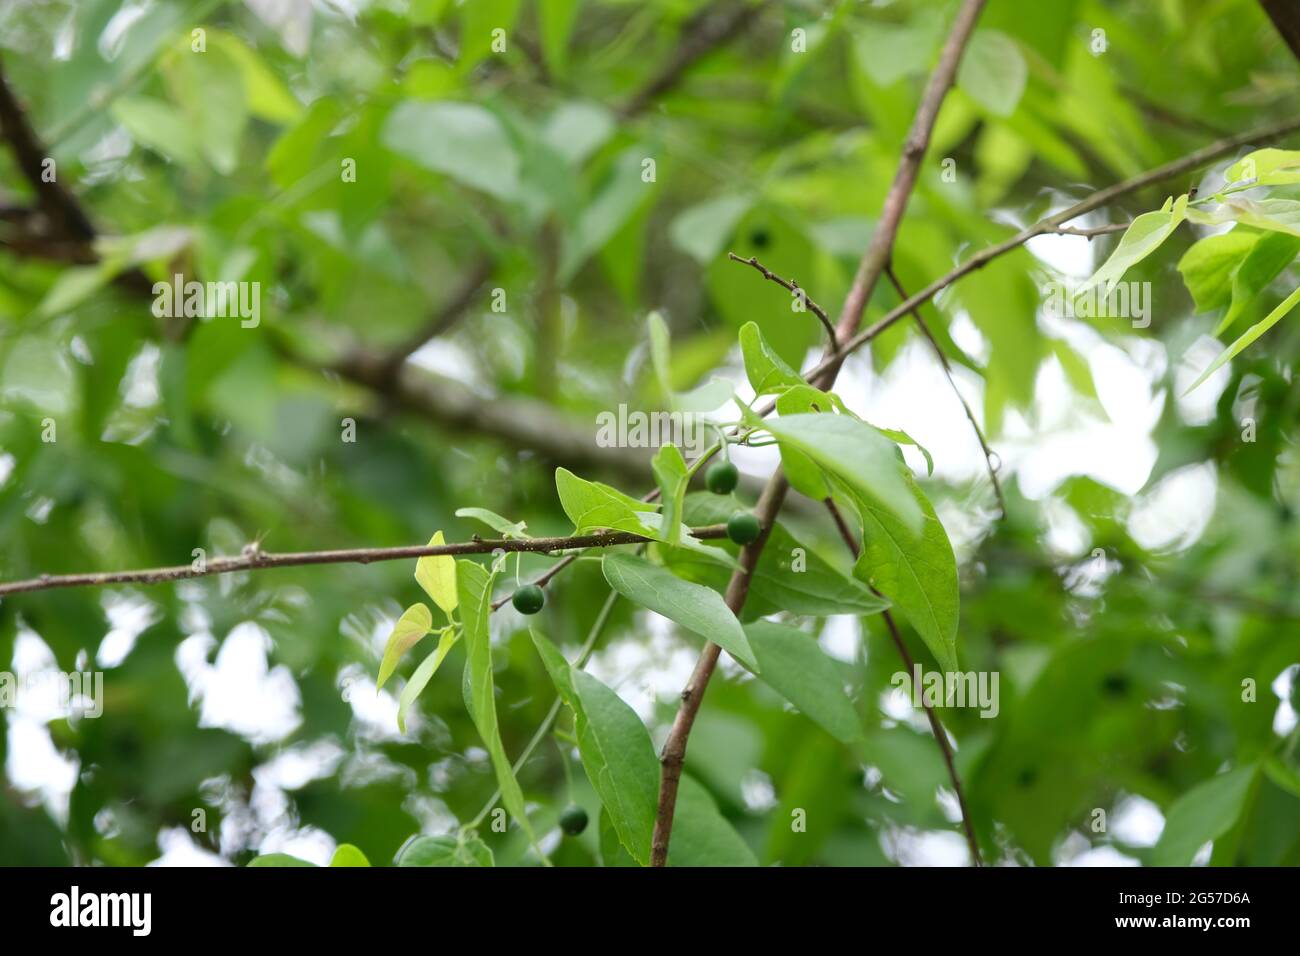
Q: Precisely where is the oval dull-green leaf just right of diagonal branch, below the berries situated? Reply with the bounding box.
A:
[745,620,862,743]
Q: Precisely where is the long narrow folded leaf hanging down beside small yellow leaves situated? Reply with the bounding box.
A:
[456,561,537,845]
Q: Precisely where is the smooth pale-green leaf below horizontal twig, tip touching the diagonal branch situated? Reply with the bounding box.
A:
[601,553,759,674]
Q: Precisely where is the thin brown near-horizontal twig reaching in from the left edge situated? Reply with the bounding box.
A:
[0,524,727,597]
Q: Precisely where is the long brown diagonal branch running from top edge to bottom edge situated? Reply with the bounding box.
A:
[650,0,985,866]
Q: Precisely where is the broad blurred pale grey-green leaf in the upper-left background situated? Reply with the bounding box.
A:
[382,101,519,199]
